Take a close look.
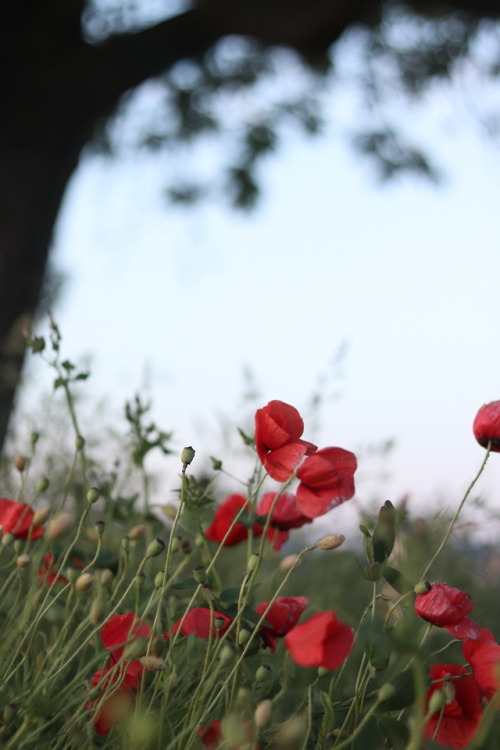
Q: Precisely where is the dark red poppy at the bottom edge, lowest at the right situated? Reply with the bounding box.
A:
[424,664,482,750]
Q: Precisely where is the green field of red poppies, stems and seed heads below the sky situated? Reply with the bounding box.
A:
[0,322,500,750]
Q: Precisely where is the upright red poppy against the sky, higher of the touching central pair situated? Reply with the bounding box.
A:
[255,401,316,482]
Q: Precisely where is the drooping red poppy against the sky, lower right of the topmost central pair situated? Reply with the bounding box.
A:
[297,448,358,518]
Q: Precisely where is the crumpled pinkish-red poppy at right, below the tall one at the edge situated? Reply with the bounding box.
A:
[415,583,481,638]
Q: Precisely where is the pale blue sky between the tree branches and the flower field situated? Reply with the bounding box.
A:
[16,81,500,540]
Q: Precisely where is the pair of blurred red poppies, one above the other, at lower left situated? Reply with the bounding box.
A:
[85,612,150,735]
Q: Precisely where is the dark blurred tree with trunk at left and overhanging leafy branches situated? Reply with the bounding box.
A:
[0,0,500,446]
